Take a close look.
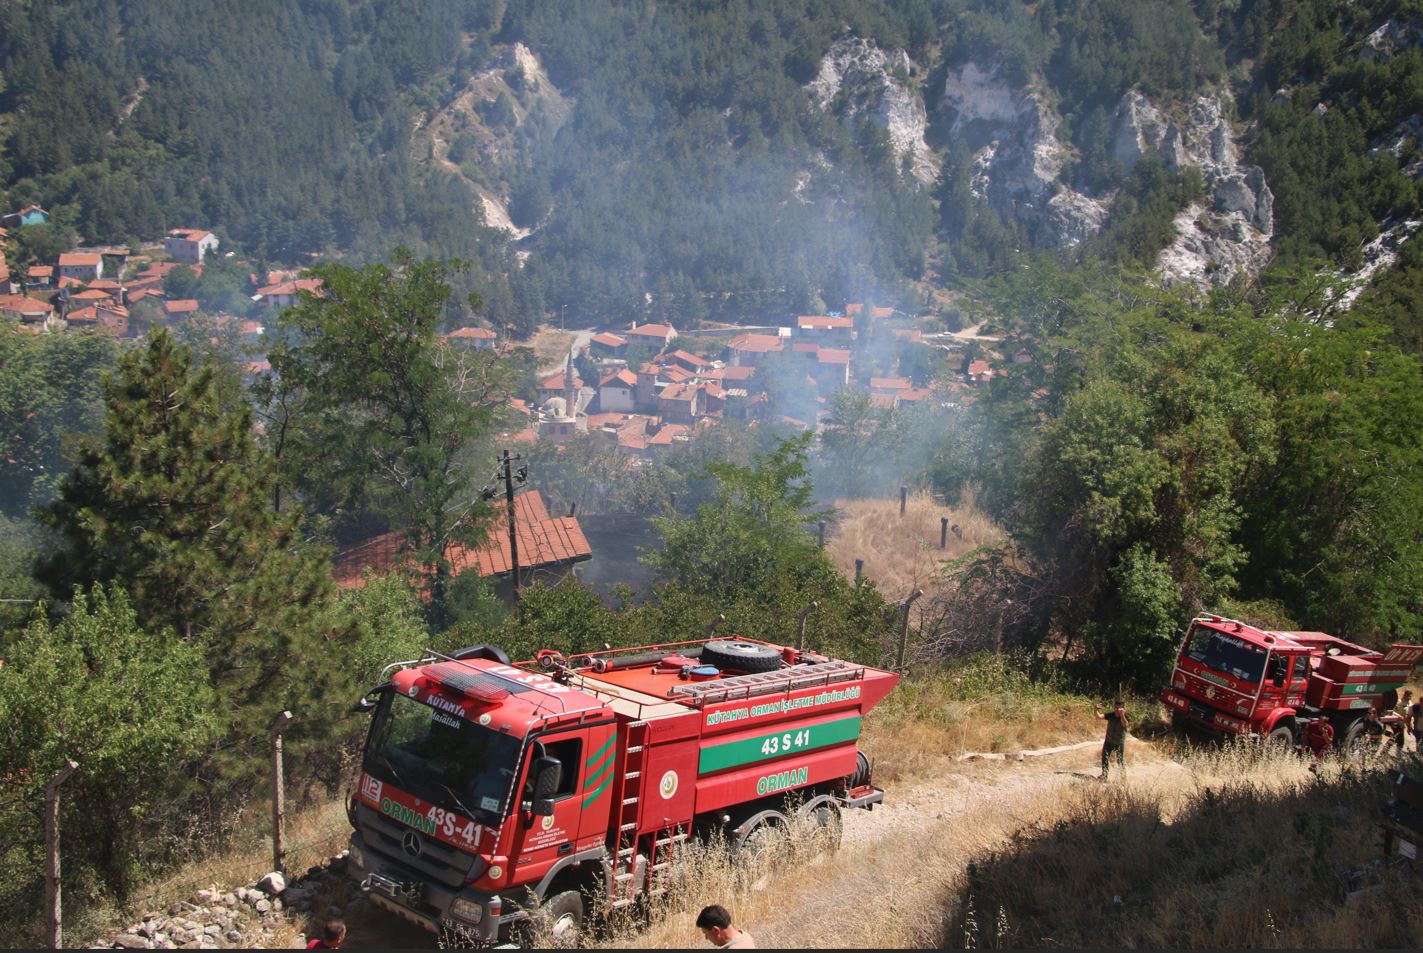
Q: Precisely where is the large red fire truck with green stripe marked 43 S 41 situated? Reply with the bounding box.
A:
[347,639,899,942]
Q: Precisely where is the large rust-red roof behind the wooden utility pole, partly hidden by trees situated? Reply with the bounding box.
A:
[334,489,593,589]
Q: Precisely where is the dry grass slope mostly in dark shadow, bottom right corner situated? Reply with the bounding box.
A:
[945,745,1423,949]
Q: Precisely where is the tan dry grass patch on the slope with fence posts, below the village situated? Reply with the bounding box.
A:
[825,492,1003,603]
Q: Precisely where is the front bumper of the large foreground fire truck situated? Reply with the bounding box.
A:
[346,832,525,943]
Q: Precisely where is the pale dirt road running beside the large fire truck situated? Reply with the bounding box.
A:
[332,740,1192,949]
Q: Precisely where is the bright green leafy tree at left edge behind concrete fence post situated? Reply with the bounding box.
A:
[0,586,225,923]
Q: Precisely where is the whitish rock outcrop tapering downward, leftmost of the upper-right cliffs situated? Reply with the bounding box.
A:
[807,37,939,183]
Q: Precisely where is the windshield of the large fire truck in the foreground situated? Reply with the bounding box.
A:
[366,691,521,826]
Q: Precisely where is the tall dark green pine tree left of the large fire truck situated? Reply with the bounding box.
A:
[37,330,333,770]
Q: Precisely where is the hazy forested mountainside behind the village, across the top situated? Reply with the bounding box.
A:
[8,0,1423,328]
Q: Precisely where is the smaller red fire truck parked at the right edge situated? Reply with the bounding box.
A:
[1161,616,1423,747]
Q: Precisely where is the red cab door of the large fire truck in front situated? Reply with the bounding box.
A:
[511,730,588,879]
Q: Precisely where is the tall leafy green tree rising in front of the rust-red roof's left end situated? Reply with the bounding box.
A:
[269,249,512,622]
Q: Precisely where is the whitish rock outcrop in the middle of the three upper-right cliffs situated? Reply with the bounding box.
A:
[939,63,1109,247]
